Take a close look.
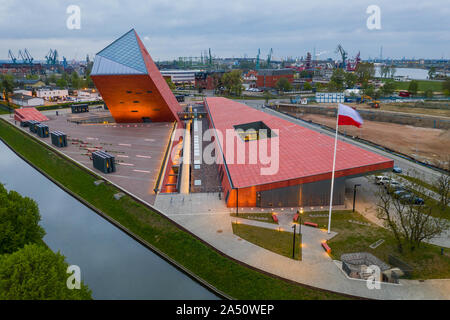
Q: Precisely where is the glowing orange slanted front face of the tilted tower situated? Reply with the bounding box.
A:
[92,75,177,122]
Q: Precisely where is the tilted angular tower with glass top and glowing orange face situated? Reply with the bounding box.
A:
[91,29,181,123]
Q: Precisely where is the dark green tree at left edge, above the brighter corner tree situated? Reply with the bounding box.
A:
[0,184,45,254]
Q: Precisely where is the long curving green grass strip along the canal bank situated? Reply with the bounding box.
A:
[0,119,346,300]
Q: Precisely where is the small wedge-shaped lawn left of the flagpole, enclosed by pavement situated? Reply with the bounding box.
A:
[233,223,302,260]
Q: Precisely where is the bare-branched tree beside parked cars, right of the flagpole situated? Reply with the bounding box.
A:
[377,175,449,252]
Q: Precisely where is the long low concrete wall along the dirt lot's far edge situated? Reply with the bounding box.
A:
[278,104,450,130]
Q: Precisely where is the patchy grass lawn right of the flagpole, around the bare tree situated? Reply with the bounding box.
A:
[305,211,450,279]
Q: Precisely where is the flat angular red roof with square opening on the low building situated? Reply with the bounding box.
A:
[206,97,393,188]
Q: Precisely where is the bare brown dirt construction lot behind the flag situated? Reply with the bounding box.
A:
[297,114,450,167]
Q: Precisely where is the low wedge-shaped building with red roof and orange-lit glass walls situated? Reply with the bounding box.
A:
[205,98,393,207]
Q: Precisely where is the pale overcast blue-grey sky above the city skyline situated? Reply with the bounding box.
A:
[0,0,450,60]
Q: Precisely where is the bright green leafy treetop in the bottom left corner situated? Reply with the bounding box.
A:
[0,244,92,300]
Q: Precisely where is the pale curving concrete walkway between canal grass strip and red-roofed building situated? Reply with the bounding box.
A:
[155,193,450,299]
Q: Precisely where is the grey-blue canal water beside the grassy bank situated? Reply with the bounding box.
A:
[0,141,218,300]
